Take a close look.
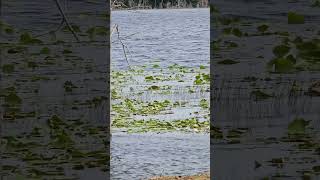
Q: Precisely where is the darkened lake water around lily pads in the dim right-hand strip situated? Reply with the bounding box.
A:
[211,0,320,179]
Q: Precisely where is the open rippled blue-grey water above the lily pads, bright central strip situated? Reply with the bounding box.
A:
[111,8,210,68]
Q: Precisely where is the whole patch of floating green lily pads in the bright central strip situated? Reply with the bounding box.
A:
[111,64,210,132]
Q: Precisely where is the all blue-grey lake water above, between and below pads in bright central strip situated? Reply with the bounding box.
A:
[111,9,210,179]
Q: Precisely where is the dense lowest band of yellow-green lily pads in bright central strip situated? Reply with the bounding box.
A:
[112,118,209,132]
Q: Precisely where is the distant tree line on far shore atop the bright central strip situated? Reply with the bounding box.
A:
[112,0,208,9]
